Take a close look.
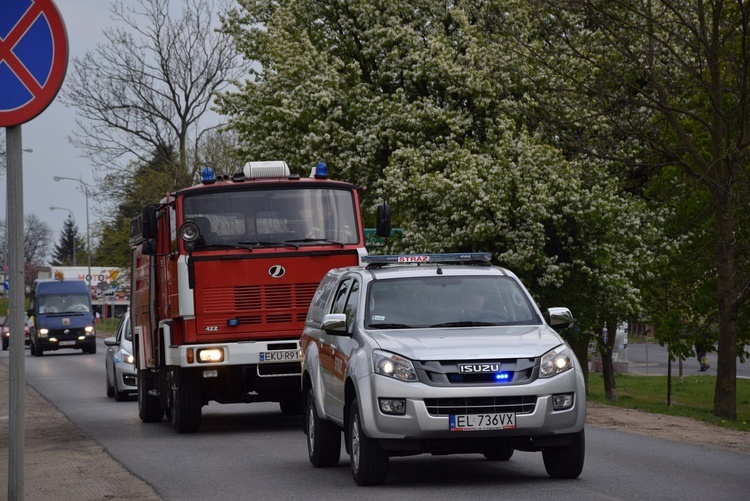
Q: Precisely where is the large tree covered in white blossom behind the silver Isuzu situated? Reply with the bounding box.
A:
[218,0,658,394]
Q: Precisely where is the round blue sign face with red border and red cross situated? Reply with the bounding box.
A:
[0,0,68,127]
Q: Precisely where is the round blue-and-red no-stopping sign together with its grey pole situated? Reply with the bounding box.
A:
[0,0,68,501]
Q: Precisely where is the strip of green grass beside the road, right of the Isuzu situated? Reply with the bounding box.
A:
[588,372,750,432]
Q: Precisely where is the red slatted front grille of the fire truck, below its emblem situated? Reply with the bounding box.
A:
[203,283,318,324]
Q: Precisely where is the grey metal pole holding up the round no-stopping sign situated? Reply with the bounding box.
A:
[5,125,26,501]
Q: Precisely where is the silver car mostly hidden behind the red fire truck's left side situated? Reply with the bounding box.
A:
[104,311,138,402]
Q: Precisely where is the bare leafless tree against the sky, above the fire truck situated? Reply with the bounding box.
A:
[61,0,244,189]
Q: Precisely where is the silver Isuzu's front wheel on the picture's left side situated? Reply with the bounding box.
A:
[349,399,388,485]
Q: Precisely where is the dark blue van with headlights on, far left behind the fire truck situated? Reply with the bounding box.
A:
[28,279,96,357]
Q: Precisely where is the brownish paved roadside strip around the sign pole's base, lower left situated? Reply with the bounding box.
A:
[0,364,161,501]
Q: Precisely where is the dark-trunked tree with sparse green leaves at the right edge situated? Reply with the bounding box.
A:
[523,0,750,419]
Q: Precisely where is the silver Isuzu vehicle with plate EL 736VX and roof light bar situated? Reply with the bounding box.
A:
[300,253,586,485]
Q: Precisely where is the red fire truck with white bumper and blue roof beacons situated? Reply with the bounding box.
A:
[131,162,388,433]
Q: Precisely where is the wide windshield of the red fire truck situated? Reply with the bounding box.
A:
[182,187,359,248]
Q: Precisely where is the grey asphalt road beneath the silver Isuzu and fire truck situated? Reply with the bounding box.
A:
[0,340,750,501]
